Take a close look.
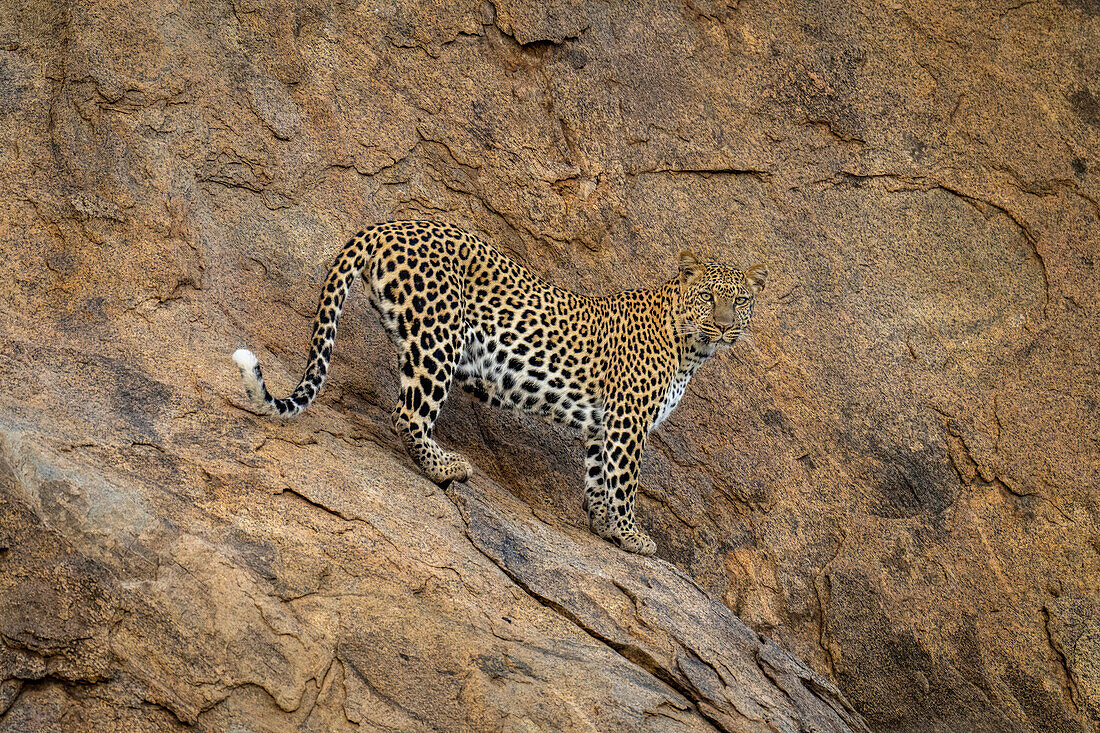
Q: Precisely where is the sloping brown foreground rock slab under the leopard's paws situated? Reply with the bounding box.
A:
[0,420,866,731]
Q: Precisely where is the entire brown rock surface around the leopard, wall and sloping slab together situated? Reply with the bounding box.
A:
[0,0,1100,733]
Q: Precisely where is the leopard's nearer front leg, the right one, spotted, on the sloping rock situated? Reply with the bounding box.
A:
[600,408,657,555]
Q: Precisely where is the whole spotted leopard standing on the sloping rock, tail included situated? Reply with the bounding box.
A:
[232,221,768,555]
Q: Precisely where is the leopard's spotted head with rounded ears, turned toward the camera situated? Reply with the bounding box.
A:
[680,252,768,347]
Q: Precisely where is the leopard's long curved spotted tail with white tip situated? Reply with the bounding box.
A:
[233,232,367,417]
